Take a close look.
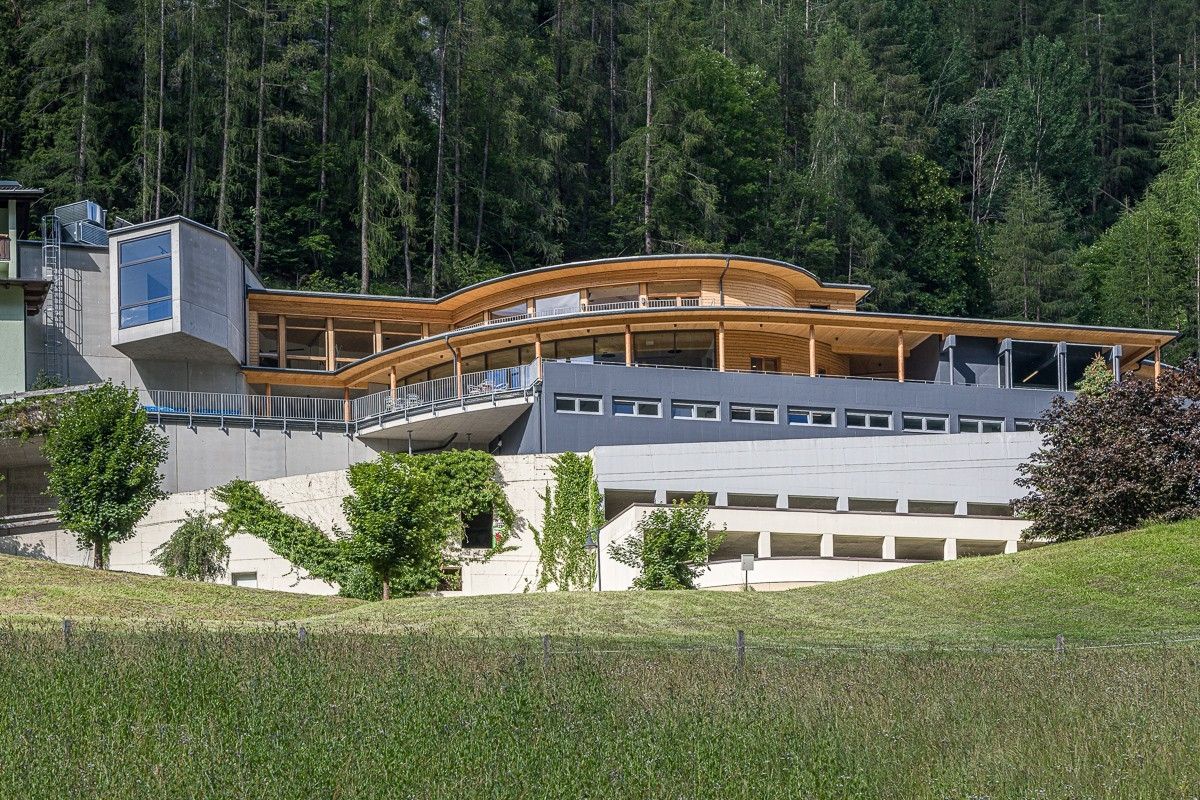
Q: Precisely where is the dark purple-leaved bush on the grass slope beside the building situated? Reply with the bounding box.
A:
[1015,360,1200,541]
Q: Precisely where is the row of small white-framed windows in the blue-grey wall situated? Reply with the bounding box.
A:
[554,395,1033,433]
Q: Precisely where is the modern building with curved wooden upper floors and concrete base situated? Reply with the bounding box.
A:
[0,195,1176,591]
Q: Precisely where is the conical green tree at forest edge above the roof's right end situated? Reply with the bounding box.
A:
[988,176,1080,321]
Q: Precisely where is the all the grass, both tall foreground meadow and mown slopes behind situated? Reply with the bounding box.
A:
[0,522,1200,800]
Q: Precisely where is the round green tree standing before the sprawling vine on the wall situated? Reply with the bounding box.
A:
[342,453,454,600]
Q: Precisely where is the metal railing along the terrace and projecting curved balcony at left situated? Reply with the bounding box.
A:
[145,362,538,433]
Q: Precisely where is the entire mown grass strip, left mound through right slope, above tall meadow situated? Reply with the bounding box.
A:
[0,522,1200,645]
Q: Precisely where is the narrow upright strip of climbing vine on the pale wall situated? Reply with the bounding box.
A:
[533,452,604,591]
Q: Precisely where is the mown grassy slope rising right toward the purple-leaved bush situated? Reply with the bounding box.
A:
[322,522,1200,644]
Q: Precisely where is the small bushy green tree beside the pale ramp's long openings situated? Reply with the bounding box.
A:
[608,493,725,589]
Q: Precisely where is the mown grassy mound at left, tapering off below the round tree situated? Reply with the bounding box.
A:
[0,555,360,624]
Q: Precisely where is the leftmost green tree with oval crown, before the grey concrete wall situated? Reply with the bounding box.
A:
[43,383,167,570]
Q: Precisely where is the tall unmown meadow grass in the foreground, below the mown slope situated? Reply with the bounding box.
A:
[0,628,1200,800]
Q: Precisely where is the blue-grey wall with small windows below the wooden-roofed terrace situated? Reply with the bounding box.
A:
[502,362,1057,452]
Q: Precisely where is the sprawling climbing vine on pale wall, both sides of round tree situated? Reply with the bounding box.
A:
[214,450,517,600]
